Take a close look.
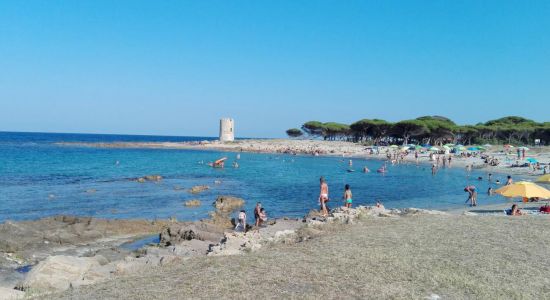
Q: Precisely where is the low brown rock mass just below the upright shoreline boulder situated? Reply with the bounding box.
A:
[159,222,223,247]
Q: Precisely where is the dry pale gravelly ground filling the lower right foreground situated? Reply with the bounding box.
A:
[51,215,550,299]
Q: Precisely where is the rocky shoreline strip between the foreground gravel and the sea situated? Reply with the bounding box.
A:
[0,190,439,299]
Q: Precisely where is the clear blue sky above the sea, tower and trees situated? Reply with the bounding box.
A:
[0,0,550,137]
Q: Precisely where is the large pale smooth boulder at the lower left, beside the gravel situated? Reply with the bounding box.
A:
[17,255,110,291]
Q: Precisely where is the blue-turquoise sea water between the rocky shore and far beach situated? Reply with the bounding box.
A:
[0,132,516,222]
